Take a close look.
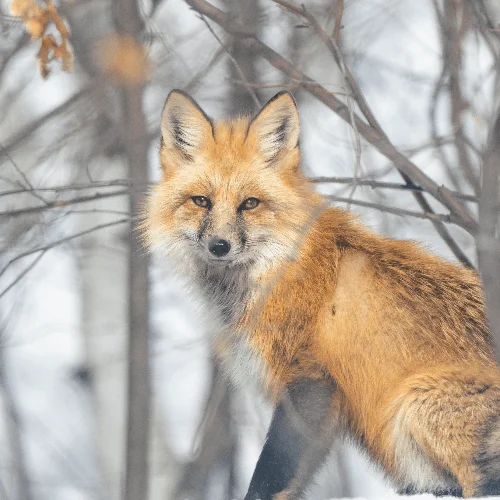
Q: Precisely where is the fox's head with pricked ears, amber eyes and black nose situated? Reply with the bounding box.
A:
[145,90,320,278]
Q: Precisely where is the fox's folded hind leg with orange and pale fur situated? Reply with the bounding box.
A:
[392,368,500,497]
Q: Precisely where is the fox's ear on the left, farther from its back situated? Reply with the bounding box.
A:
[161,90,213,159]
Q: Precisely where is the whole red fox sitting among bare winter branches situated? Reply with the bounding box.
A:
[144,90,500,500]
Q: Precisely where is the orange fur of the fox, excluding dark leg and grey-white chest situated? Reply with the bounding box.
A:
[145,91,500,498]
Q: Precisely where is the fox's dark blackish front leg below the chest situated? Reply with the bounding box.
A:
[245,380,339,500]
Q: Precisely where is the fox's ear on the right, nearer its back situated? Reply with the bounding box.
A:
[248,91,300,161]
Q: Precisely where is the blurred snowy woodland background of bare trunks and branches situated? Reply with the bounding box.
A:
[0,0,500,500]
